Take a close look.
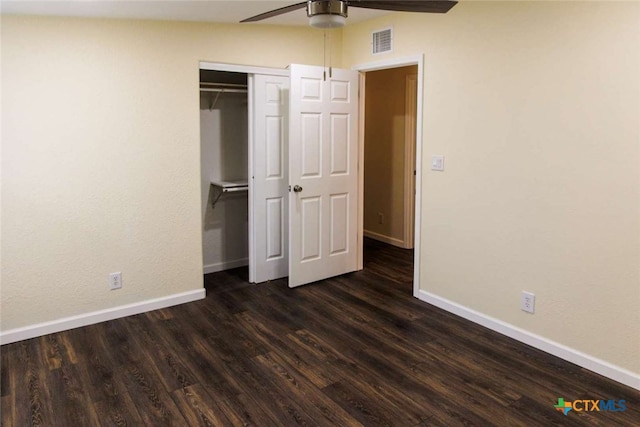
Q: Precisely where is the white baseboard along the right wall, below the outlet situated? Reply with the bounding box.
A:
[415,290,640,390]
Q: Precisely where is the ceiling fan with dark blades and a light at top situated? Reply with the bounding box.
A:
[240,0,458,28]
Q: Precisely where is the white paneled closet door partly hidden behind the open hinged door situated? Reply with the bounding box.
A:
[249,74,289,283]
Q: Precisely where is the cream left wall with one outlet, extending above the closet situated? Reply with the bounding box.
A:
[0,16,341,332]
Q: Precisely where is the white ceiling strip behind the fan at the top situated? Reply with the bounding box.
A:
[0,0,389,25]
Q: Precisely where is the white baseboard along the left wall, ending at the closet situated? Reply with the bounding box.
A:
[0,288,206,344]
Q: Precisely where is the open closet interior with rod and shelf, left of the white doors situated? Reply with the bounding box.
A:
[200,69,249,274]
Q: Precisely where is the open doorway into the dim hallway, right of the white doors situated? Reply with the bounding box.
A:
[363,65,418,249]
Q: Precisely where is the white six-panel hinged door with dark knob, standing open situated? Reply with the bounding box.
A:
[289,64,358,287]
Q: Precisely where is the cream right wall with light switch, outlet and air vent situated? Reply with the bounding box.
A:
[343,2,640,375]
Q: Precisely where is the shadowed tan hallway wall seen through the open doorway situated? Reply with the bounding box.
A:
[364,66,418,246]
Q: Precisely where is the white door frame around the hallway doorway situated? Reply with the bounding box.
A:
[352,54,424,298]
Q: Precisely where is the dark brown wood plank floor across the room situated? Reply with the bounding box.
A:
[1,240,640,427]
